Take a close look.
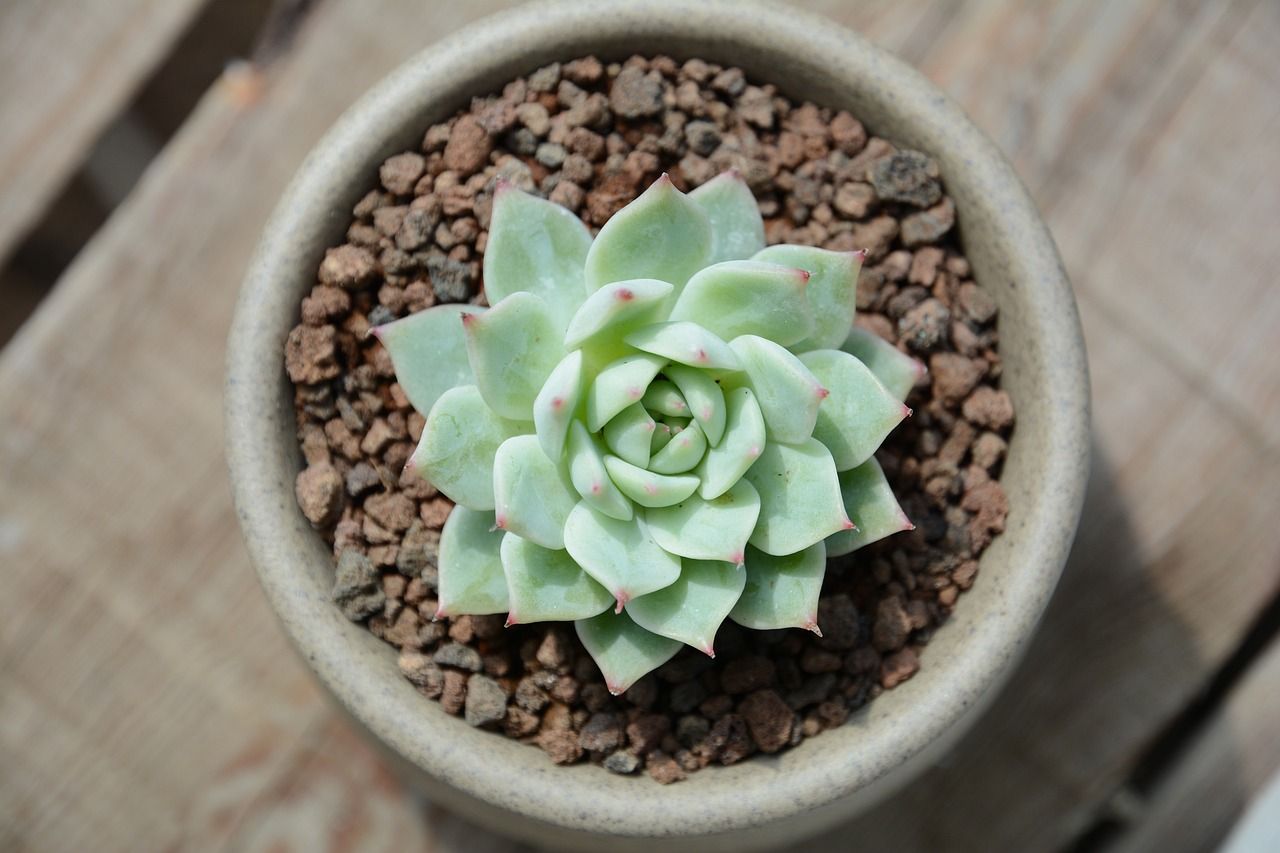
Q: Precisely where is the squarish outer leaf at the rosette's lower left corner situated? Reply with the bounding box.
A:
[435,506,507,619]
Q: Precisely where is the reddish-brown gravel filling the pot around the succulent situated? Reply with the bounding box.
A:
[284,56,1014,783]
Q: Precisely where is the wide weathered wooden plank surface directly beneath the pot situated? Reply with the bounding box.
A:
[0,0,1280,850]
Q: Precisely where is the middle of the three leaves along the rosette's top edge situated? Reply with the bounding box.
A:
[586,174,712,293]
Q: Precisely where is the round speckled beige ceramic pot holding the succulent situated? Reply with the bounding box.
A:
[227,0,1089,850]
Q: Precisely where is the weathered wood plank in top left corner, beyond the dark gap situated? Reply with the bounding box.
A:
[0,0,206,264]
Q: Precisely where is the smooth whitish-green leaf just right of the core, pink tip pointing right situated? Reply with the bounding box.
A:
[730,334,827,444]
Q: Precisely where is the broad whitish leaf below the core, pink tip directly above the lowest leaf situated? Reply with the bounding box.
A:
[564,503,680,611]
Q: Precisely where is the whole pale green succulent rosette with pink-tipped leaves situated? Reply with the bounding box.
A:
[375,173,922,693]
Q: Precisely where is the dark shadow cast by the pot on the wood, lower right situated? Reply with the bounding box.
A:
[786,441,1244,853]
